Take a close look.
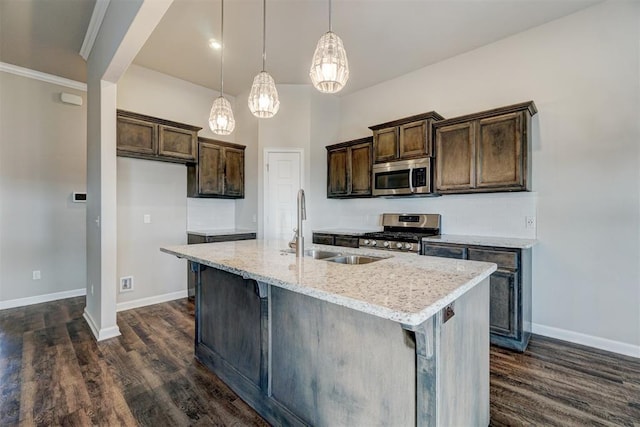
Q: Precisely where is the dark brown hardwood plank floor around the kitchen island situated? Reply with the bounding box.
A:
[0,297,640,427]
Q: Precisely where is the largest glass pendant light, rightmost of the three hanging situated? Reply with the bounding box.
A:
[309,0,349,93]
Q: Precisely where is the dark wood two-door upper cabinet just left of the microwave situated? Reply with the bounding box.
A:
[327,137,373,198]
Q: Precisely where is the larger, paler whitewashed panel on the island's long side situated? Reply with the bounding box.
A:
[271,287,416,426]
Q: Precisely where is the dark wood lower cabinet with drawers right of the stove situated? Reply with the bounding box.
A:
[421,241,531,352]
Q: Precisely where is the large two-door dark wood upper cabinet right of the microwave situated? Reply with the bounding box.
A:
[434,101,537,194]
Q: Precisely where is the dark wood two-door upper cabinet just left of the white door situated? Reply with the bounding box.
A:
[187,137,246,199]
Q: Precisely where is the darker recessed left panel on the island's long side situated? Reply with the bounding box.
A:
[197,268,262,386]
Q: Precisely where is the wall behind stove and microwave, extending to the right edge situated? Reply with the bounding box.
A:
[340,2,640,356]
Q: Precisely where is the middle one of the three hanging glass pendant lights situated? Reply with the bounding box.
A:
[248,0,280,119]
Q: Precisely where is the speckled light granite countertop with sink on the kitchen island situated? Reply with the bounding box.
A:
[160,240,496,326]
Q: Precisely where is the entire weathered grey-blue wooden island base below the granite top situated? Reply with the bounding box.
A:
[195,264,489,426]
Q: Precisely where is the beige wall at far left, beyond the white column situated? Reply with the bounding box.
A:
[0,72,87,308]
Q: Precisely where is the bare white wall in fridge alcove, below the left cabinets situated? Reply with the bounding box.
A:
[117,157,187,309]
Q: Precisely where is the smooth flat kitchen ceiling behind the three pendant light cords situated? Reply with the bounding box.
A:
[135,0,598,95]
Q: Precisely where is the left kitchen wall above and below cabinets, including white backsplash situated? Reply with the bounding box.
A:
[117,65,240,309]
